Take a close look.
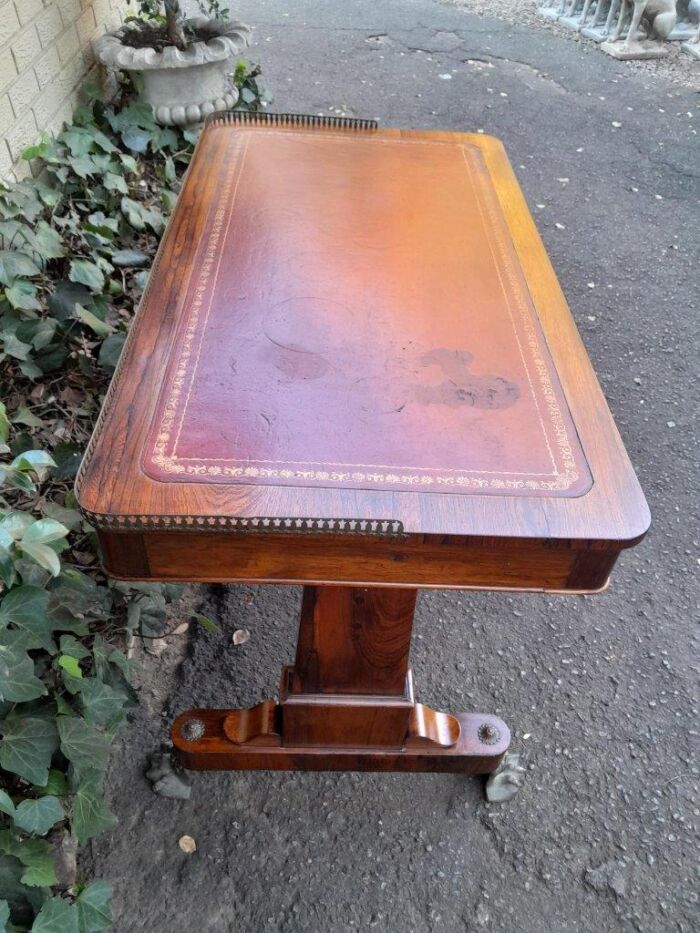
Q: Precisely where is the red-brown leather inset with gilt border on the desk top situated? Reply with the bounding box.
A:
[143,127,591,497]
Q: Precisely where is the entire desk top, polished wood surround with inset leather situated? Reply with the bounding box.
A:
[76,114,649,552]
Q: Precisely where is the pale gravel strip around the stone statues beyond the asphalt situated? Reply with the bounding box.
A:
[440,0,700,91]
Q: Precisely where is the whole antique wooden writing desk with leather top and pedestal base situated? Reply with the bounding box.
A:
[77,114,648,772]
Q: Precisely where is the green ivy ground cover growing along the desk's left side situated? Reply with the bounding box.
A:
[0,76,216,933]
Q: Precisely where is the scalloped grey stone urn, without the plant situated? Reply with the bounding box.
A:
[93,17,250,126]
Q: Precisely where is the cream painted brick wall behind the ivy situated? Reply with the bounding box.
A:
[0,0,126,178]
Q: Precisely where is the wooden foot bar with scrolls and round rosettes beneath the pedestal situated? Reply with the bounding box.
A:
[172,701,510,774]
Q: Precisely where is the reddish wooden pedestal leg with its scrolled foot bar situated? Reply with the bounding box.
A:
[172,586,510,774]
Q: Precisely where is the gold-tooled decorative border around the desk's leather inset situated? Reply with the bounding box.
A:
[144,132,590,495]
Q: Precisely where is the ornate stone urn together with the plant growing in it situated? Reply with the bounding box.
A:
[94,0,250,126]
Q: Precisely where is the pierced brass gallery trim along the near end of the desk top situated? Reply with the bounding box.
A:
[80,508,405,538]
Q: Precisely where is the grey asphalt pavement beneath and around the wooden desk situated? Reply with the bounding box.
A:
[82,0,700,933]
